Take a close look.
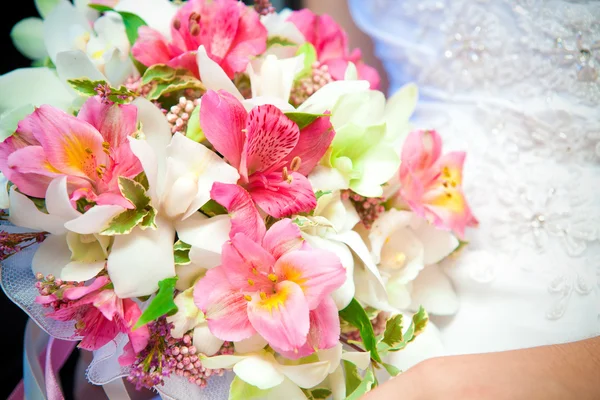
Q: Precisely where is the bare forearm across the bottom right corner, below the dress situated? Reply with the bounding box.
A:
[363,337,600,400]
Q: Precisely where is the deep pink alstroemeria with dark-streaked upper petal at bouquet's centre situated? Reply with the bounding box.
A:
[200,90,335,240]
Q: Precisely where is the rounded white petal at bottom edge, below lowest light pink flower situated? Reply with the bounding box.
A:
[233,353,284,390]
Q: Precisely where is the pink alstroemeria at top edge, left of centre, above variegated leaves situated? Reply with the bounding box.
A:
[136,0,267,79]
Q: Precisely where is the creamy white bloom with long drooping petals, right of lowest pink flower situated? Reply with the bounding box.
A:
[301,192,389,310]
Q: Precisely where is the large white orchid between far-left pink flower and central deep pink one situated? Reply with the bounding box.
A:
[107,98,239,298]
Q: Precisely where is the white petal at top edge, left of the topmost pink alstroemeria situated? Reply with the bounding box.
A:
[115,0,178,39]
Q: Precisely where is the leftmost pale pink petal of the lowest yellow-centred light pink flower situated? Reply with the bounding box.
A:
[194,267,255,342]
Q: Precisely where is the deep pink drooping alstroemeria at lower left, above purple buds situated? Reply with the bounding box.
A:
[36,276,149,361]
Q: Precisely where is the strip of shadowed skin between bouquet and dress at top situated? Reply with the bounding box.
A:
[303,0,388,92]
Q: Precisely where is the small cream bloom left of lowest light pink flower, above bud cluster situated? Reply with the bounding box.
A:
[167,288,224,356]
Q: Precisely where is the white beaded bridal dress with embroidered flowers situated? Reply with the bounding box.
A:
[349,0,600,354]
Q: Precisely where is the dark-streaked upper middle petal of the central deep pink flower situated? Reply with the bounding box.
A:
[240,104,300,175]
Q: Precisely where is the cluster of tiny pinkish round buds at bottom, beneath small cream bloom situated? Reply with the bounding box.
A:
[170,334,233,388]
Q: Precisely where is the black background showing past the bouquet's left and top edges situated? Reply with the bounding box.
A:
[0,0,301,400]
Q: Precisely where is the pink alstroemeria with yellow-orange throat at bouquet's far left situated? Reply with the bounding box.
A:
[0,97,142,208]
